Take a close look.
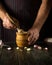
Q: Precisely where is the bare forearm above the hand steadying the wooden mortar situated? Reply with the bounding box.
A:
[33,2,51,31]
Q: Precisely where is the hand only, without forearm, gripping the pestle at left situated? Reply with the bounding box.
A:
[3,14,15,29]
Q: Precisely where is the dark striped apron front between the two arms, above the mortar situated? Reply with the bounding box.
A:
[4,0,41,30]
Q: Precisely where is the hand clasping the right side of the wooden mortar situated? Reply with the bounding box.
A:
[28,28,39,45]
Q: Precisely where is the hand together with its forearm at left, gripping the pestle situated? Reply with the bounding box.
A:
[0,4,15,29]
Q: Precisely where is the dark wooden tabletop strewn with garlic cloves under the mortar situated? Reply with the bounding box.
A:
[0,42,52,65]
